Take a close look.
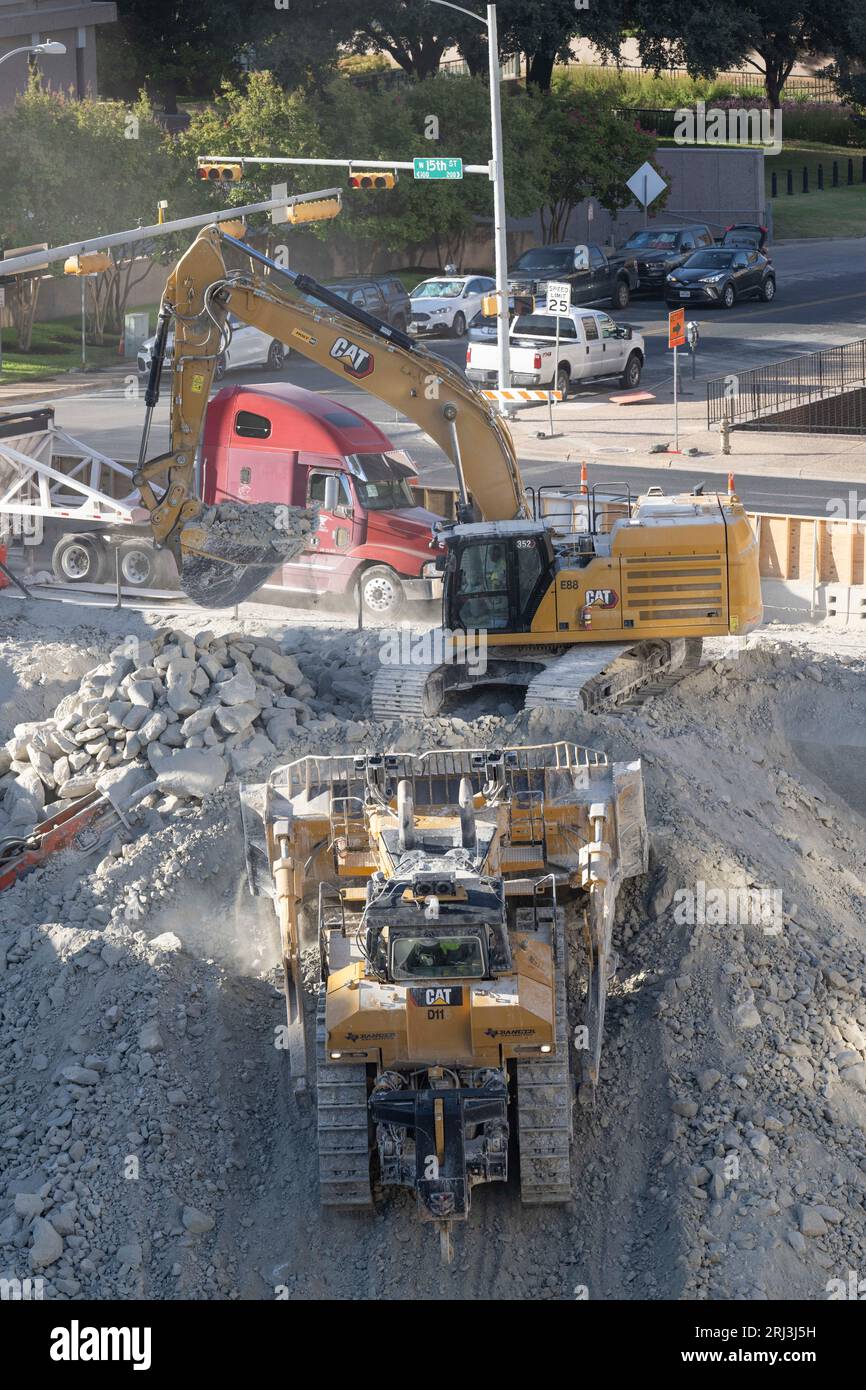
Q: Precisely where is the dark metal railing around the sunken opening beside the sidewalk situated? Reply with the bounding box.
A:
[706,338,866,434]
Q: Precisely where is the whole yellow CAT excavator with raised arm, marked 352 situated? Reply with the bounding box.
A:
[135,227,762,719]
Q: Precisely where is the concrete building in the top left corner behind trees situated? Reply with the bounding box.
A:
[0,0,117,108]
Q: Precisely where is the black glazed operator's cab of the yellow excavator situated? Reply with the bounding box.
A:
[445,521,555,632]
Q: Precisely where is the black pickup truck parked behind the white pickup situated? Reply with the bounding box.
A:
[509,242,638,309]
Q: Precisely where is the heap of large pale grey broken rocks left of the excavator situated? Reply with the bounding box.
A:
[0,630,325,827]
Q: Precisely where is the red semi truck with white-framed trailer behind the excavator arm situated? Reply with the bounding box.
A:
[0,382,442,617]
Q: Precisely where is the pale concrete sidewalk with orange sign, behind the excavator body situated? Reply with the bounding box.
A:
[510,379,866,481]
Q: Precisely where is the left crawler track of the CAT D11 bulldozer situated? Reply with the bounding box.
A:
[316,984,373,1211]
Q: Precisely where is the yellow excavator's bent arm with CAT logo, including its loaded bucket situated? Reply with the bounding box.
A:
[135,227,530,605]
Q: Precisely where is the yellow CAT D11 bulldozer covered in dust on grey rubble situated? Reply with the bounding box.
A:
[242,742,648,1258]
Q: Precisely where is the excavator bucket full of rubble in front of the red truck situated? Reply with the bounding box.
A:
[174,502,316,607]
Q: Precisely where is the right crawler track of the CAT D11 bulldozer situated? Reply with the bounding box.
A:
[516,908,574,1207]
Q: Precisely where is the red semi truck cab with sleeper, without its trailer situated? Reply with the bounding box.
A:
[202,382,442,617]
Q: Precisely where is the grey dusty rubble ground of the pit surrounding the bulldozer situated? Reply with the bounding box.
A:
[0,598,866,1301]
